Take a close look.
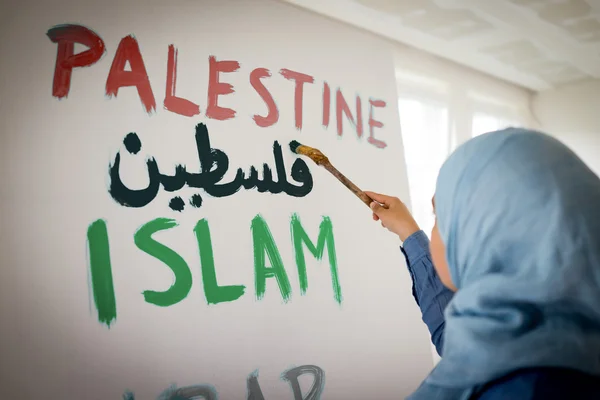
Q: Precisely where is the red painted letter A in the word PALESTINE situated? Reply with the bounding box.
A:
[106,35,156,113]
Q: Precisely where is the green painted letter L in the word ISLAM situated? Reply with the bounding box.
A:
[194,219,246,304]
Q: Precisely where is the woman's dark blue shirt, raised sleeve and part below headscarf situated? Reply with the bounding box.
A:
[401,231,600,400]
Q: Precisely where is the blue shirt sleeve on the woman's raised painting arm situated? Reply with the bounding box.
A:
[401,231,454,356]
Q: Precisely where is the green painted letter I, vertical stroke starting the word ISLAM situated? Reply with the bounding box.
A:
[87,219,117,328]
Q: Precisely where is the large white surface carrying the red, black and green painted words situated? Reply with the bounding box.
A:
[0,0,432,400]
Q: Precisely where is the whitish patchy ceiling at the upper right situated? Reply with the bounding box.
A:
[284,0,600,91]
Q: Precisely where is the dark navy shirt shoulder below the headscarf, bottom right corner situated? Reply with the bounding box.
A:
[472,368,600,400]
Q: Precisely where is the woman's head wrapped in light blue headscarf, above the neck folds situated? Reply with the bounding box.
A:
[431,128,600,290]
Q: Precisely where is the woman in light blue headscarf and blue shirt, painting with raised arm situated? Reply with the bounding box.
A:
[370,128,600,400]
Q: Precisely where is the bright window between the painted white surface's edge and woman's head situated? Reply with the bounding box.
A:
[398,98,450,239]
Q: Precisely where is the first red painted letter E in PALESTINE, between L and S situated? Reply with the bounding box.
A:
[206,56,240,121]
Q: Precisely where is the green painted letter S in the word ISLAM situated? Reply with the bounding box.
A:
[133,218,192,307]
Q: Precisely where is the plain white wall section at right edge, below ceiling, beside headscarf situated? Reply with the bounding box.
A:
[532,79,600,174]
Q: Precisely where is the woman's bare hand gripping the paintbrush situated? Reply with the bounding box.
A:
[365,192,419,241]
